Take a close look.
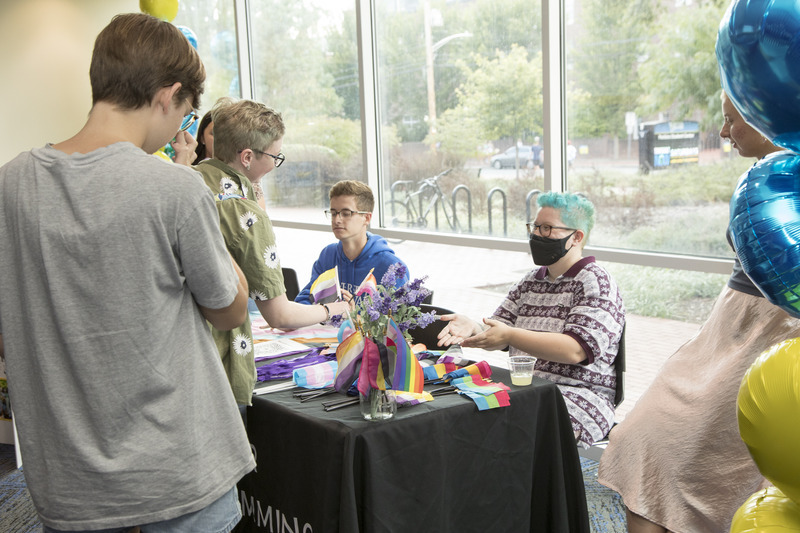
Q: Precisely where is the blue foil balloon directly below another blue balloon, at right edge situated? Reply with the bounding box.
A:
[730,152,800,318]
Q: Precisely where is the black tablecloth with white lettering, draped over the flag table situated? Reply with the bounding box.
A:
[237,368,589,533]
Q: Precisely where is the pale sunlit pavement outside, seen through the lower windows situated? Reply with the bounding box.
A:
[275,227,700,421]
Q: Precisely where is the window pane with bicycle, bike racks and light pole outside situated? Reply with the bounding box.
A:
[375,0,543,238]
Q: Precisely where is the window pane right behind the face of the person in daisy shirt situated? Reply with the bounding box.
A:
[249,0,364,220]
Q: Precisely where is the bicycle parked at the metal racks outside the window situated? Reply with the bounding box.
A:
[386,168,461,231]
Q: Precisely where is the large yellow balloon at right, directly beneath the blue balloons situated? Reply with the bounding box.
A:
[737,338,800,503]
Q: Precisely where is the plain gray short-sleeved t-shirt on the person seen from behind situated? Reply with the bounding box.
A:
[0,143,255,529]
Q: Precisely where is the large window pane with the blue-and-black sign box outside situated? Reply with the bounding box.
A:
[565,0,753,258]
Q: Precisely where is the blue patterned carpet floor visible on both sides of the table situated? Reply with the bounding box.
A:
[0,444,626,533]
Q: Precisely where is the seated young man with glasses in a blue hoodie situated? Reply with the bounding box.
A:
[294,180,409,304]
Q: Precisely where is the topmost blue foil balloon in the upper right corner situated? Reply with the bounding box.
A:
[716,0,800,151]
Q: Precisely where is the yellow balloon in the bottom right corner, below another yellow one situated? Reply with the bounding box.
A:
[730,487,800,533]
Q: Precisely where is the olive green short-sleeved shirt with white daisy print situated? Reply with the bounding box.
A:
[195,159,286,405]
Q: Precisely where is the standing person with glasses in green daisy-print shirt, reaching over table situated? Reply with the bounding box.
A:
[195,100,350,405]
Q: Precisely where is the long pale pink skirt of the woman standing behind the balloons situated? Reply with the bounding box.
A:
[598,287,800,533]
